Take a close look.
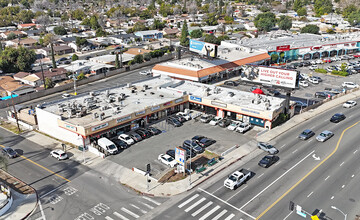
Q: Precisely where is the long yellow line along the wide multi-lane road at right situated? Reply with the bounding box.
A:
[256,121,360,220]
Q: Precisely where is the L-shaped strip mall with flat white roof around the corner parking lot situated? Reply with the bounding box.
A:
[36,77,285,145]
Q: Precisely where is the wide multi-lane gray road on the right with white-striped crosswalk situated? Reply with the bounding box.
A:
[148,97,360,220]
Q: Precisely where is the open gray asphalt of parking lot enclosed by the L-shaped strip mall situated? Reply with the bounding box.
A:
[107,114,262,179]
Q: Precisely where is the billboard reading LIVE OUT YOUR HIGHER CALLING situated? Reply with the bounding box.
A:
[241,65,298,89]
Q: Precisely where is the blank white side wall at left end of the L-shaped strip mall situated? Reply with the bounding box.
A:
[36,108,83,146]
